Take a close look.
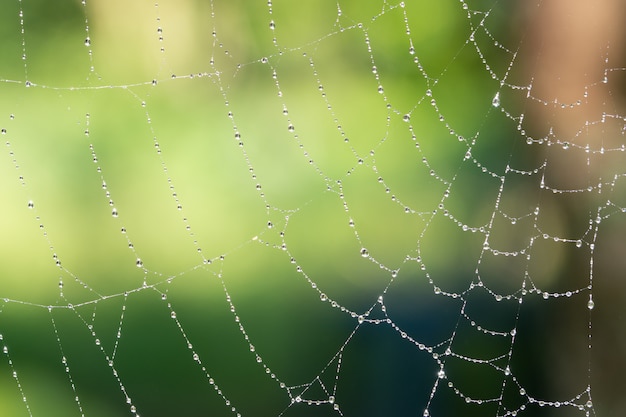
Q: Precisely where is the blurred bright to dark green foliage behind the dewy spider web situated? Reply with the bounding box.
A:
[0,0,612,416]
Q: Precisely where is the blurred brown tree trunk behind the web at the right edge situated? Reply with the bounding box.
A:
[522,0,626,416]
